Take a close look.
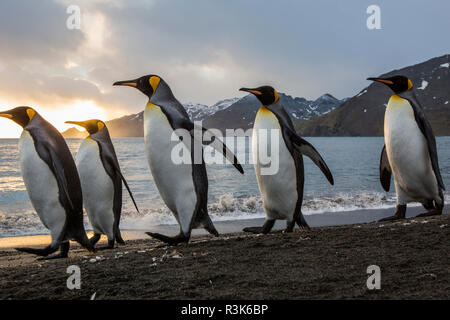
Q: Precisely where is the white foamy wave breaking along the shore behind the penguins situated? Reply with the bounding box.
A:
[0,192,450,237]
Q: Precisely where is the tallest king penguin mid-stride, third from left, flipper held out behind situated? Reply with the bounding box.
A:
[114,75,244,245]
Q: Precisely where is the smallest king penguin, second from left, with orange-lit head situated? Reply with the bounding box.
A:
[66,119,139,249]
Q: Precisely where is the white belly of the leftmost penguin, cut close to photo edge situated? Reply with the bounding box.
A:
[19,130,66,238]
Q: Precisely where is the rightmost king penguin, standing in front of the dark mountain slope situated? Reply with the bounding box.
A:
[367,75,445,221]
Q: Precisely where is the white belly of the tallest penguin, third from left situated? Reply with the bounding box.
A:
[144,103,197,232]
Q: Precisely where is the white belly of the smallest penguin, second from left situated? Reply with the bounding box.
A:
[76,138,114,239]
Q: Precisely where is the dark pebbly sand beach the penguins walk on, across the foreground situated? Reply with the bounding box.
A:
[0,215,450,299]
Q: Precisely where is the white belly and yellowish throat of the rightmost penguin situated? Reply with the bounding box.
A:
[384,95,438,202]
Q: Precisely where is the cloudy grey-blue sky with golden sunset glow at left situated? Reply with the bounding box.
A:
[0,0,450,137]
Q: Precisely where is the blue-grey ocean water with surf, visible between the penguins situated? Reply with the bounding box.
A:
[0,137,450,237]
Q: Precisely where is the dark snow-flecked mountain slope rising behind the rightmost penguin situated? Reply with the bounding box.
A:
[297,54,450,136]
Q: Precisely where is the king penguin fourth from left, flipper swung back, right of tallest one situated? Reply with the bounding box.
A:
[240,86,334,234]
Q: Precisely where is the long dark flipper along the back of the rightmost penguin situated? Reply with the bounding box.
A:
[400,90,445,190]
